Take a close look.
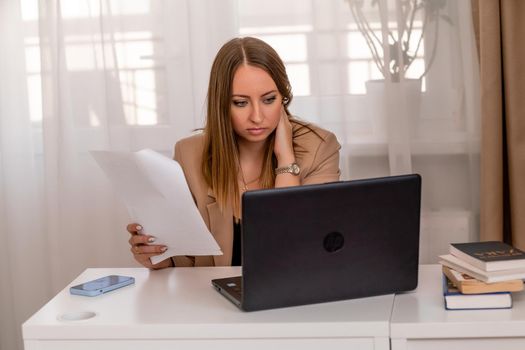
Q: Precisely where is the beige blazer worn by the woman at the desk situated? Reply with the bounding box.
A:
[174,125,341,266]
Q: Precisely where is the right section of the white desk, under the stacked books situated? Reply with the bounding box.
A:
[390,265,525,350]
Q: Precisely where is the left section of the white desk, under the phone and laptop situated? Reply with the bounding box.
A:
[22,267,394,350]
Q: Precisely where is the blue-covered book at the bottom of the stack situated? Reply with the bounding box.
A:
[443,275,512,310]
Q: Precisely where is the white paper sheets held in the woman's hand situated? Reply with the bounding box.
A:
[90,149,222,264]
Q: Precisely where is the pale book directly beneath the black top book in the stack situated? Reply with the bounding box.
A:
[439,254,525,283]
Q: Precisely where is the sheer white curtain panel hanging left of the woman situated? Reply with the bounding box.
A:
[0,0,236,350]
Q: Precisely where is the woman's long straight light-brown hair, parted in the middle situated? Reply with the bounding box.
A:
[202,37,316,215]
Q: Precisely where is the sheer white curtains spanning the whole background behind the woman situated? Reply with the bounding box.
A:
[0,0,479,350]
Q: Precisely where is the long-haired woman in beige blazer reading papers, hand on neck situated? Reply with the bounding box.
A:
[128,37,340,269]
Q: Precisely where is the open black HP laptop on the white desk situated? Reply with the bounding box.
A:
[212,174,421,311]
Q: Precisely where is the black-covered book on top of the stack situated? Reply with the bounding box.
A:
[450,241,525,271]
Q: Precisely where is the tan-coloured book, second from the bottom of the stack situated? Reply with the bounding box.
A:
[443,266,523,294]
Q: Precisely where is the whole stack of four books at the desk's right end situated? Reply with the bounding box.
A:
[440,241,525,310]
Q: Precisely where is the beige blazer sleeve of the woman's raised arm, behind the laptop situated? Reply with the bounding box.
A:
[302,133,341,185]
